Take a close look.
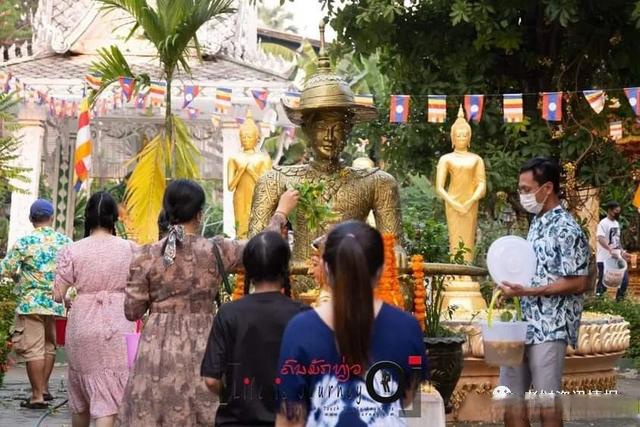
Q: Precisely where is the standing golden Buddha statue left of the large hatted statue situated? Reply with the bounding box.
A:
[227,111,271,239]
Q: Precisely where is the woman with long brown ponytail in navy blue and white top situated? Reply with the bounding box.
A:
[276,221,427,426]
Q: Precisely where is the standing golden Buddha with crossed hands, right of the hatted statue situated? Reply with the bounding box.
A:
[436,106,487,311]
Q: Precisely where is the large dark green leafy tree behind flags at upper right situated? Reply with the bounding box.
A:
[326,0,640,214]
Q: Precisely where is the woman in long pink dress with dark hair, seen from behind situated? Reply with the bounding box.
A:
[54,192,134,427]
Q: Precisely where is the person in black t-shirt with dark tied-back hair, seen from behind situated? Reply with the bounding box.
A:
[200,231,308,426]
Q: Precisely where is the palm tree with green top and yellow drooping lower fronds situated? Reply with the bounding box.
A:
[91,0,234,243]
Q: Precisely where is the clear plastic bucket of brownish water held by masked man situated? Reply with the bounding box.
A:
[480,321,527,366]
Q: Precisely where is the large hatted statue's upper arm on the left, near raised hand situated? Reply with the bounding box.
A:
[249,170,284,237]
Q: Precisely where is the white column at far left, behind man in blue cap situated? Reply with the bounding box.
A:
[8,105,44,248]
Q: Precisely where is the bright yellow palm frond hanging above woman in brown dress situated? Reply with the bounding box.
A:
[125,133,168,244]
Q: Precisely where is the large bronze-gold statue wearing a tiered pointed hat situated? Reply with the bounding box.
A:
[249,25,402,262]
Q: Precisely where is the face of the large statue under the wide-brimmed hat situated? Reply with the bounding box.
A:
[303,110,352,160]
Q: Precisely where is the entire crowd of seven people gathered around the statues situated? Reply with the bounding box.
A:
[0,158,629,427]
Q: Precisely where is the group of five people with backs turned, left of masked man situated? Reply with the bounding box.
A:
[0,180,426,427]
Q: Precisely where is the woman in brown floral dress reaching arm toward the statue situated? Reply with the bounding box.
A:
[118,179,298,427]
